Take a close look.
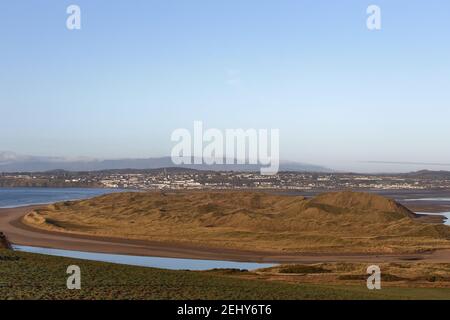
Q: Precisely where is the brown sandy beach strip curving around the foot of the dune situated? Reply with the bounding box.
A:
[0,206,450,263]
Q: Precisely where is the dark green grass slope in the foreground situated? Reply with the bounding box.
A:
[0,250,450,300]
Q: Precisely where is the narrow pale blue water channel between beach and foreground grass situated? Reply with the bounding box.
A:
[14,246,274,270]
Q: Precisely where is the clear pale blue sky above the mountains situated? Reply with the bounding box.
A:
[0,0,450,172]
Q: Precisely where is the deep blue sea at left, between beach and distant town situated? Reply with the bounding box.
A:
[0,188,118,208]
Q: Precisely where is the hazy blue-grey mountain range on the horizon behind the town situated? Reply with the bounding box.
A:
[0,152,333,172]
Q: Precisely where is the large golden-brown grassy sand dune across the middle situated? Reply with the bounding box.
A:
[24,192,450,253]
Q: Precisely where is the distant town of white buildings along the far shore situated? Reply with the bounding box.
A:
[0,168,450,191]
